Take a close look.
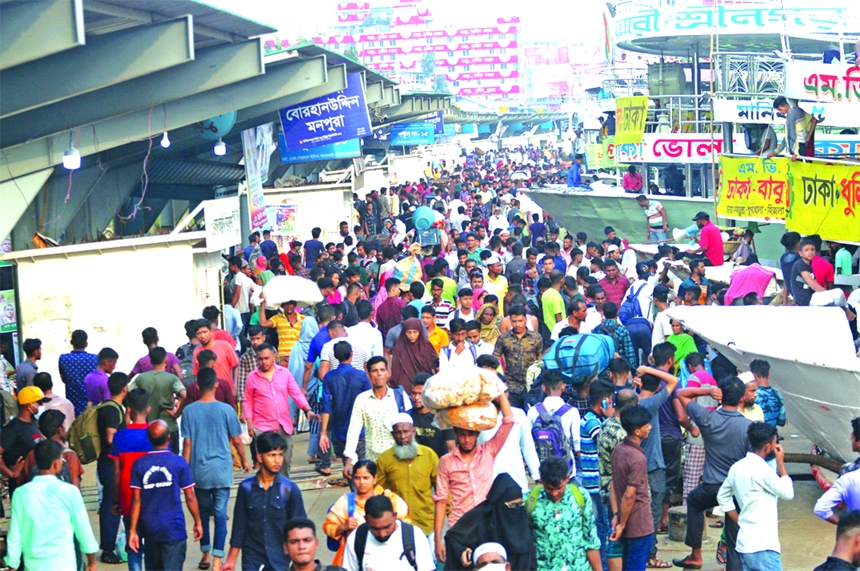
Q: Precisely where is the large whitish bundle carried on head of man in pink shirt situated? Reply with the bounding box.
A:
[421,367,505,411]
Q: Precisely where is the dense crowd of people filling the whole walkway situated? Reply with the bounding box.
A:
[0,150,860,571]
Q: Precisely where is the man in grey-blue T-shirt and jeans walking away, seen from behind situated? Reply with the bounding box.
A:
[181,369,249,569]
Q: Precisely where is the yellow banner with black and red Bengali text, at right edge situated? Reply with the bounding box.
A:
[785,161,860,242]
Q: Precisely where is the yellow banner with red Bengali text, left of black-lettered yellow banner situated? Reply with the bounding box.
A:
[717,155,789,221]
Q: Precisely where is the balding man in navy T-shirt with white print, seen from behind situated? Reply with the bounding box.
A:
[128,419,203,571]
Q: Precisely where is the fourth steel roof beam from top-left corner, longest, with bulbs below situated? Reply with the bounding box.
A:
[0,56,328,182]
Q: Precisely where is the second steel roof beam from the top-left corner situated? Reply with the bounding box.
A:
[0,16,194,118]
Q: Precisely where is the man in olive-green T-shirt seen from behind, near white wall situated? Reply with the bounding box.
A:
[130,347,185,454]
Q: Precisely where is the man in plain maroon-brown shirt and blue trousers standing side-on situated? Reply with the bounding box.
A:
[609,404,654,571]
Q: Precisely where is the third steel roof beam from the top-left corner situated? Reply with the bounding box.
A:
[0,39,266,149]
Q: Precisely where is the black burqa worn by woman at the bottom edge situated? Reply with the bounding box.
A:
[445,473,537,571]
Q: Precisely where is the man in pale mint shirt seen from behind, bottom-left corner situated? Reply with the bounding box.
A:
[5,440,99,571]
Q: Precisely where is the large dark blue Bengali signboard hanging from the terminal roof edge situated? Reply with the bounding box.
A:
[279,73,372,151]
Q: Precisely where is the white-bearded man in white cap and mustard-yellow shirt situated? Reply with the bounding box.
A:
[376,413,439,545]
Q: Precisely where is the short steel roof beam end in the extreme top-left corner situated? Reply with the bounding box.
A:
[0,0,86,70]
